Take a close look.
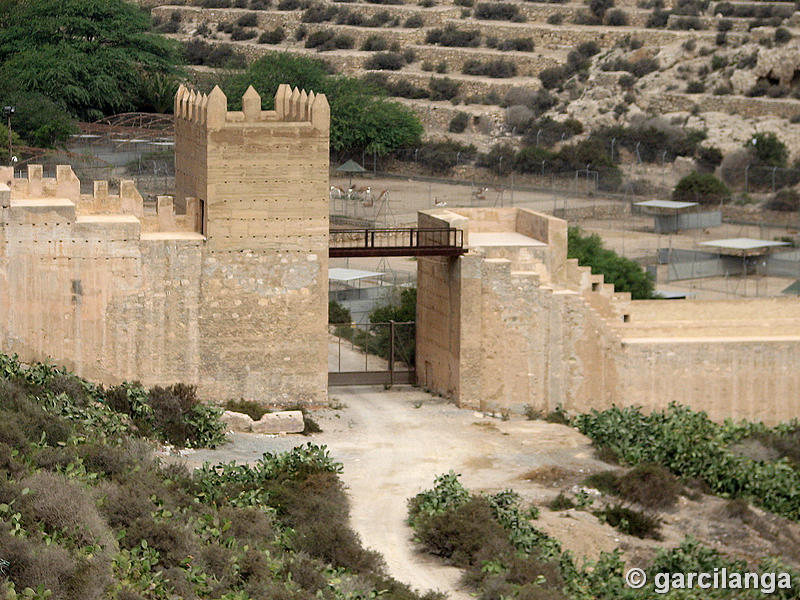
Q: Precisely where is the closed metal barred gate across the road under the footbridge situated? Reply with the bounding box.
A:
[328,321,416,386]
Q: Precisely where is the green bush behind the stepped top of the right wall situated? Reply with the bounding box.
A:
[567,227,654,300]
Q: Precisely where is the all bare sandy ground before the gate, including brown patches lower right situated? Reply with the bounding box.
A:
[173,387,800,600]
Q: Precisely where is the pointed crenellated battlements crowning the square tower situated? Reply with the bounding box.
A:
[175,83,331,132]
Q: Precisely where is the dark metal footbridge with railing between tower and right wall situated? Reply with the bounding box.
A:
[330,227,465,257]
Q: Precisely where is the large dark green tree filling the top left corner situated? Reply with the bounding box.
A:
[0,0,179,119]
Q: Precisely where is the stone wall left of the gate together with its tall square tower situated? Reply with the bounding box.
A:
[0,85,330,402]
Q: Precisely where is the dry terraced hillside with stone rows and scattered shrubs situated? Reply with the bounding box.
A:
[145,0,800,184]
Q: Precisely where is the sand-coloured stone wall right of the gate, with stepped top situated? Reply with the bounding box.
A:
[417,208,800,423]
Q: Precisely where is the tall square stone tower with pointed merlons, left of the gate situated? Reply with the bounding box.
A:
[175,84,330,403]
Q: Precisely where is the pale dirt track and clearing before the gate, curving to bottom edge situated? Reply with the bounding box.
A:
[187,387,608,600]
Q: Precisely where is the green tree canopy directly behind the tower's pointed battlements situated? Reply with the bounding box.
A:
[221,52,423,155]
